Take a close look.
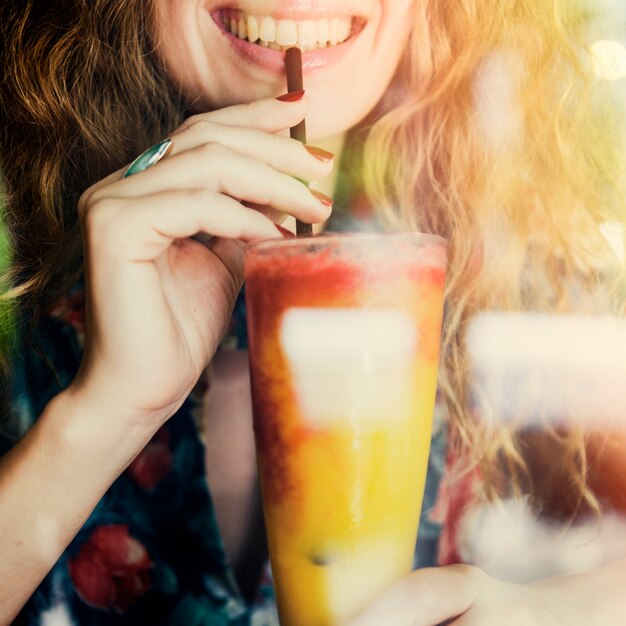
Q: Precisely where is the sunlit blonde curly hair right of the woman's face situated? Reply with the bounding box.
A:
[363,0,626,514]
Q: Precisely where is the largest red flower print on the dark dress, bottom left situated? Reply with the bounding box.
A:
[68,524,152,613]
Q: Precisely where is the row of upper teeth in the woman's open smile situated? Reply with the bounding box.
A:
[222,10,352,50]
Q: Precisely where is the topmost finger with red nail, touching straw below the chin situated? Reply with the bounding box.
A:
[170,95,309,137]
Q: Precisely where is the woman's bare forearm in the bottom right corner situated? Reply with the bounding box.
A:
[535,560,626,626]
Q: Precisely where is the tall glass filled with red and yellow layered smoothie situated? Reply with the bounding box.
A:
[245,233,446,626]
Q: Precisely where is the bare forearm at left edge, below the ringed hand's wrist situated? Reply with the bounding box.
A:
[0,391,157,625]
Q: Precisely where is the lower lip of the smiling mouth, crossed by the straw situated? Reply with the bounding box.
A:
[212,11,362,74]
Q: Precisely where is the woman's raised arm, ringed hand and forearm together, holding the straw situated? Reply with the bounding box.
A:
[0,99,332,624]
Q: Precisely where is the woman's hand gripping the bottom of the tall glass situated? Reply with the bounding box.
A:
[346,565,564,626]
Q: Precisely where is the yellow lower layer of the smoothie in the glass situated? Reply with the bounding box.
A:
[261,363,436,626]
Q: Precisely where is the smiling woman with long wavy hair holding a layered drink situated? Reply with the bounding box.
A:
[0,0,626,626]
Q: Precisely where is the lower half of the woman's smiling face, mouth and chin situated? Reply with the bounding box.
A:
[155,0,416,141]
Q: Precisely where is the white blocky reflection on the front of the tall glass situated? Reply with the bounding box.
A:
[280,307,418,425]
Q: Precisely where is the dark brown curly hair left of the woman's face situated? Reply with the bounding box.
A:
[0,0,182,317]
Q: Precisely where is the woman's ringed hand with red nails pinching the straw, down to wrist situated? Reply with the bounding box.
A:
[72,98,332,428]
